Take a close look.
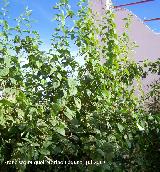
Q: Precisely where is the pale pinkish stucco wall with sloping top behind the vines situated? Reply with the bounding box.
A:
[89,0,160,92]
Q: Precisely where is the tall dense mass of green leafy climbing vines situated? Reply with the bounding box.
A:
[0,0,159,171]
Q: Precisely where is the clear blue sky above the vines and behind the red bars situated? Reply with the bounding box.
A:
[0,0,160,45]
